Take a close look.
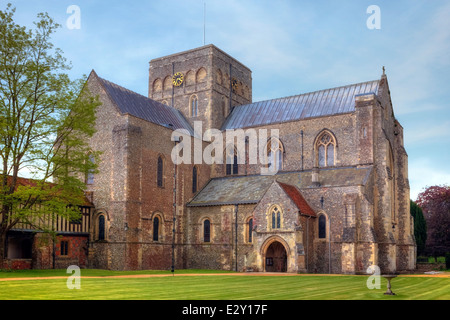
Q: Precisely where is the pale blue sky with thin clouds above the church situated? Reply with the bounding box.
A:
[5,0,450,200]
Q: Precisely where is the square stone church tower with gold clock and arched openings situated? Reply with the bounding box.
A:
[148,45,252,133]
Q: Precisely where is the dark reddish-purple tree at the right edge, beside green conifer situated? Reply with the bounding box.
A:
[416,185,450,257]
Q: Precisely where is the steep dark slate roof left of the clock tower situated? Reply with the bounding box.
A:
[91,71,194,135]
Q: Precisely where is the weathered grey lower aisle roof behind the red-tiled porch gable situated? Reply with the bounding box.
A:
[187,166,372,210]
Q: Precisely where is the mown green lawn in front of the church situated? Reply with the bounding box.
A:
[0,269,450,300]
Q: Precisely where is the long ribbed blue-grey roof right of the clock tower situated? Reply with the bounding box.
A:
[222,80,380,130]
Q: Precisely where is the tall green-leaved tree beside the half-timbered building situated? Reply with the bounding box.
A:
[0,4,99,268]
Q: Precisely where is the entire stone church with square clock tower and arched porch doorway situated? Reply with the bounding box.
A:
[1,45,416,274]
